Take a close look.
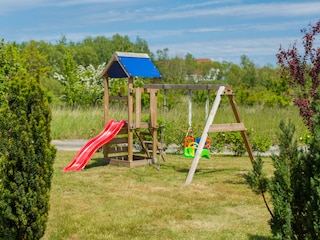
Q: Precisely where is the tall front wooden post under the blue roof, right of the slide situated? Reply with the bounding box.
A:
[128,77,134,162]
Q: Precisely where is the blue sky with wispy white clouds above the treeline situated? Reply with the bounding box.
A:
[0,0,320,66]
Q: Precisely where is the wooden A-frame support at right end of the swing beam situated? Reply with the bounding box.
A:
[185,86,254,185]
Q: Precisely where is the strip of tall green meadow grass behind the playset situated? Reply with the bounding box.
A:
[52,103,306,144]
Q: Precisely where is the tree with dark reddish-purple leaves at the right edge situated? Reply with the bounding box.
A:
[277,21,320,130]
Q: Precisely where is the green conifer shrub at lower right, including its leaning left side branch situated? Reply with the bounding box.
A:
[245,122,301,239]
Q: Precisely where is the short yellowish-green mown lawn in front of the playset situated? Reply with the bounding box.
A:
[43,151,271,240]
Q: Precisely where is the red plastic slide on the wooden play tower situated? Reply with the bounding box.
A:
[61,120,125,172]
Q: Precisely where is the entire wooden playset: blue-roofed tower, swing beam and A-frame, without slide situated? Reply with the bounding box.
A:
[101,52,254,184]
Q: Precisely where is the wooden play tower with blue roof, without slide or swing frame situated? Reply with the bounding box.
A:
[101,52,165,167]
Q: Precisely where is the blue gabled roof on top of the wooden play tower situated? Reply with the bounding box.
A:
[101,52,162,78]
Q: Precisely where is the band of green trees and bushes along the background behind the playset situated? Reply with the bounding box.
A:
[2,34,291,107]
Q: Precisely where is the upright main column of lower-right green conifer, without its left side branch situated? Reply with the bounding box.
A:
[270,121,303,239]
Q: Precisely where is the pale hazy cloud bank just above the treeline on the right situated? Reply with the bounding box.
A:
[150,34,296,65]
